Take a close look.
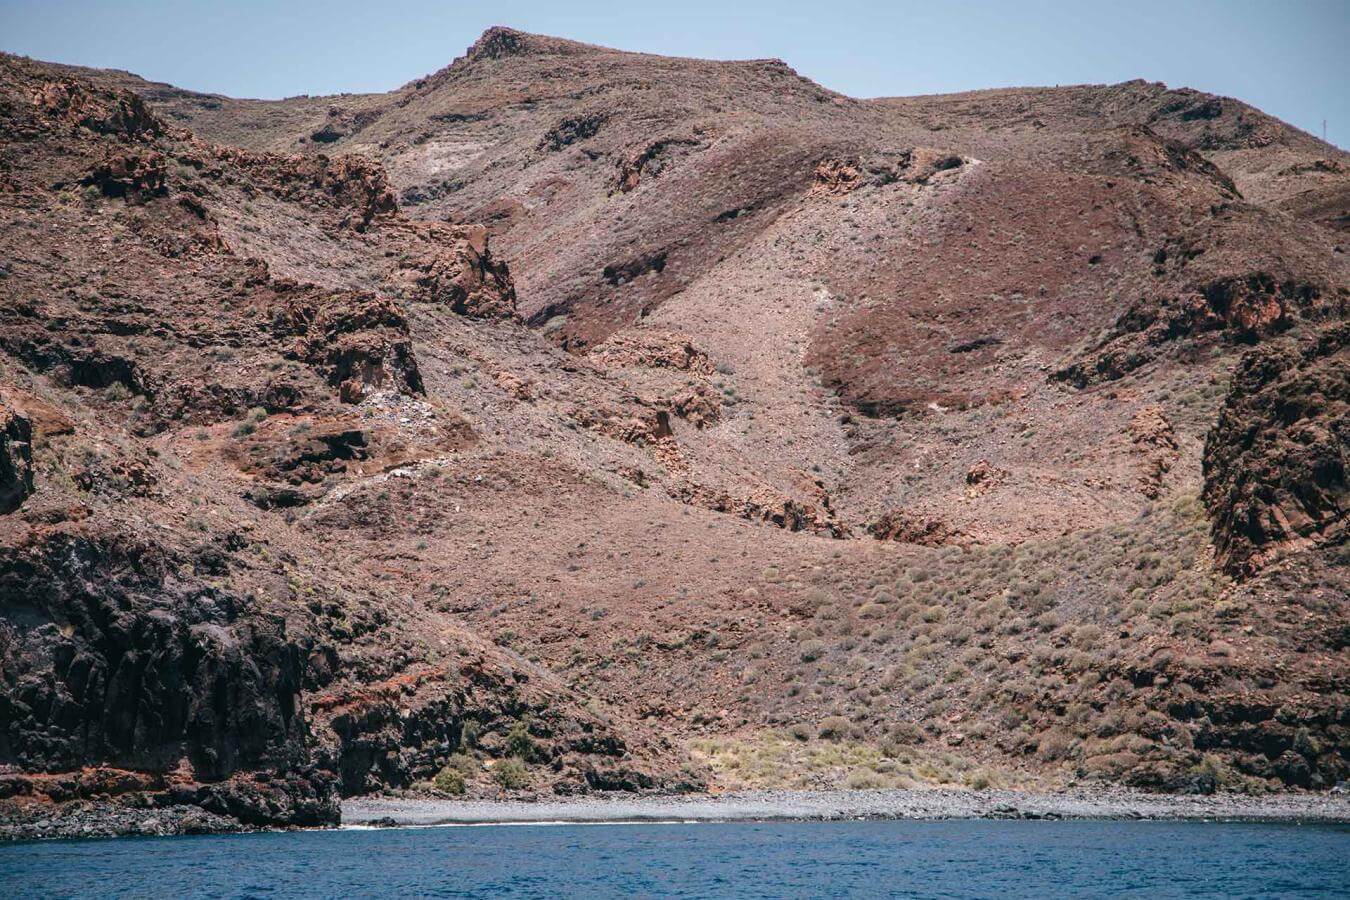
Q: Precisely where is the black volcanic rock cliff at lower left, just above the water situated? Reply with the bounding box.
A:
[0,529,336,824]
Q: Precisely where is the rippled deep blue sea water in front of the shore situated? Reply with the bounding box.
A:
[0,820,1350,899]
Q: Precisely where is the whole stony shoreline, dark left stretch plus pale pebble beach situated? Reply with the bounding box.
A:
[0,788,1350,845]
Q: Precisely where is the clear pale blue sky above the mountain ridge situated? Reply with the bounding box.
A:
[0,0,1350,147]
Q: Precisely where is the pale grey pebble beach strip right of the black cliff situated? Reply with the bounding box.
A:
[339,789,1350,827]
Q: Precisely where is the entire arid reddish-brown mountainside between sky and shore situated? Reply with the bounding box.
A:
[0,28,1350,827]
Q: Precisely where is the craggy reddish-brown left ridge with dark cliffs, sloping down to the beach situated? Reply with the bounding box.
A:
[0,52,687,827]
